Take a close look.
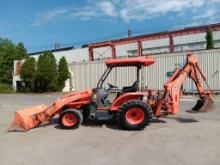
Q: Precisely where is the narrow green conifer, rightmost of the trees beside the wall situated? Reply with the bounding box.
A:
[58,57,69,91]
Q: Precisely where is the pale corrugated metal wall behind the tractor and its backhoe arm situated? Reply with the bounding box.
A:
[69,49,220,92]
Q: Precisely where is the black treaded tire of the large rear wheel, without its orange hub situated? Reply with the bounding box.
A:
[117,100,153,130]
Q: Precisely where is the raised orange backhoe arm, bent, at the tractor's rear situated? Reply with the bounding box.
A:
[158,54,212,114]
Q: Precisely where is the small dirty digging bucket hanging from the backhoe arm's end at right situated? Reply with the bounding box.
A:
[187,97,214,113]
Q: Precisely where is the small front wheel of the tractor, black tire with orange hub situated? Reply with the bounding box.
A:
[58,109,83,129]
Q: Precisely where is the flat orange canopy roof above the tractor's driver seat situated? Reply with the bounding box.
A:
[105,57,155,67]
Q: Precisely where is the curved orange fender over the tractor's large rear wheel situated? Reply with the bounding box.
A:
[110,92,145,111]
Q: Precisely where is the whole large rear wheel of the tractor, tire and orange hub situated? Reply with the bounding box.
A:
[117,100,153,130]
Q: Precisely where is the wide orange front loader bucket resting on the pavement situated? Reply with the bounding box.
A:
[8,104,48,132]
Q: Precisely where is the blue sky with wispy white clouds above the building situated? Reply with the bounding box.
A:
[0,0,220,53]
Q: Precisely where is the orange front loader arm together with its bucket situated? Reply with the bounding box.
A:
[8,90,92,131]
